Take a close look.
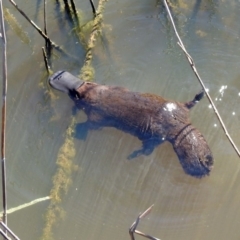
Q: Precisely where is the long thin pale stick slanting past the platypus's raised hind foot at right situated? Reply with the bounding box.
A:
[163,0,240,157]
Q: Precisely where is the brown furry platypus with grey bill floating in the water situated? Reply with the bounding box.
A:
[49,71,213,178]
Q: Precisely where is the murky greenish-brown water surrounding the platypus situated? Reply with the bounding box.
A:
[0,0,240,240]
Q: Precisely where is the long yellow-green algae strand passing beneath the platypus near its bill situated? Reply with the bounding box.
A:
[41,0,107,240]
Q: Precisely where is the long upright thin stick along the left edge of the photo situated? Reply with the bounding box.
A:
[0,0,7,227]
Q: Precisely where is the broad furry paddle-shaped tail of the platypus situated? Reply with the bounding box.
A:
[171,124,213,178]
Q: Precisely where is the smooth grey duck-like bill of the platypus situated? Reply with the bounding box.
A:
[49,71,84,94]
